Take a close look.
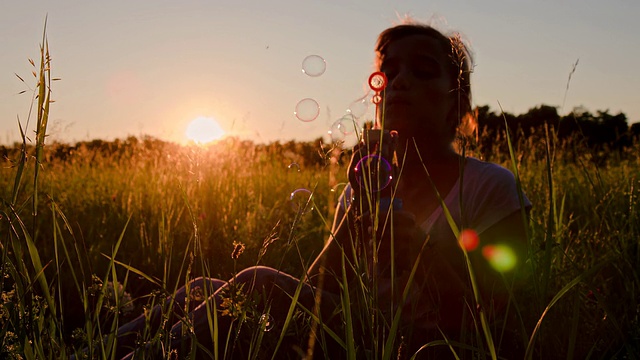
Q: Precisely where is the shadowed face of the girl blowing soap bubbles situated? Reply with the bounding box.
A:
[378,35,456,150]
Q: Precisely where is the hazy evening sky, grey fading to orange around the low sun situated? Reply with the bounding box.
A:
[0,0,640,144]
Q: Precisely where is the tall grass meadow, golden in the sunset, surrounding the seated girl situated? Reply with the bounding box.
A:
[0,31,640,359]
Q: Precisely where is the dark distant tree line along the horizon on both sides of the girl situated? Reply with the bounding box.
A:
[0,105,640,166]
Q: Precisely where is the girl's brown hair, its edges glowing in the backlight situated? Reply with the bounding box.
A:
[375,19,477,139]
